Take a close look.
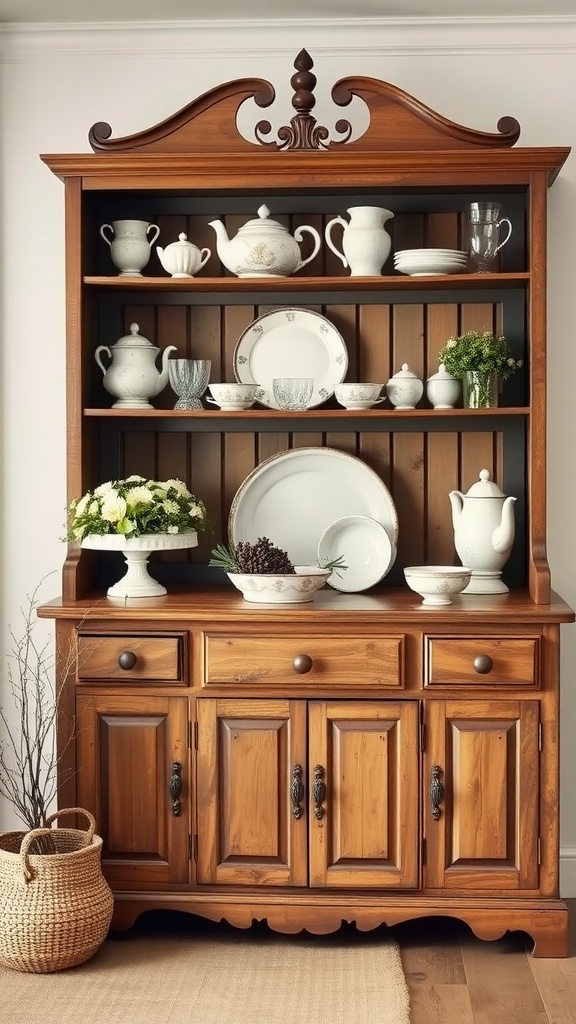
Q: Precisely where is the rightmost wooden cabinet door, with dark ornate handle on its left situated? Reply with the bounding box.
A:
[424,700,539,893]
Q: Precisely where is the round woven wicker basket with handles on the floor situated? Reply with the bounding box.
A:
[0,807,113,974]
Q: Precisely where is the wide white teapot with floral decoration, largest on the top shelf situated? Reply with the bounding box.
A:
[209,206,321,278]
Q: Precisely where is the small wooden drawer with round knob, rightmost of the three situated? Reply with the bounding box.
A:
[425,637,539,686]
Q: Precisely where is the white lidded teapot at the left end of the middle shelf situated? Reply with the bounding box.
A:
[94,324,176,409]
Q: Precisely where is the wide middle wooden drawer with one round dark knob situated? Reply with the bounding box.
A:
[204,634,404,687]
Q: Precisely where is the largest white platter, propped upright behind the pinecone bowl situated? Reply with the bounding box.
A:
[229,447,398,565]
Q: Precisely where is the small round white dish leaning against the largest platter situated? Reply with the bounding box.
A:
[318,515,396,594]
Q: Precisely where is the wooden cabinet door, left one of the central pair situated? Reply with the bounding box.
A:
[197,698,307,886]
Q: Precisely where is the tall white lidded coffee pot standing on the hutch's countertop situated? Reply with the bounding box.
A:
[449,469,516,594]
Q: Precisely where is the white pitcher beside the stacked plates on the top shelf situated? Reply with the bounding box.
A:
[324,206,394,278]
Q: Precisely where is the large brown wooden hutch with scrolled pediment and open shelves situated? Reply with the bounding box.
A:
[39,51,574,956]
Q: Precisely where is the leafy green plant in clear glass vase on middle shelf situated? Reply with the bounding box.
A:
[438,331,523,409]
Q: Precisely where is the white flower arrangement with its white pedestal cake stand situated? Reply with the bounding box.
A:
[68,474,209,598]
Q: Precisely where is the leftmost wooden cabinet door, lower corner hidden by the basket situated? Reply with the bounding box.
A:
[77,693,191,889]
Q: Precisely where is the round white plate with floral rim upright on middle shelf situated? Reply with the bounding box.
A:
[234,307,348,409]
